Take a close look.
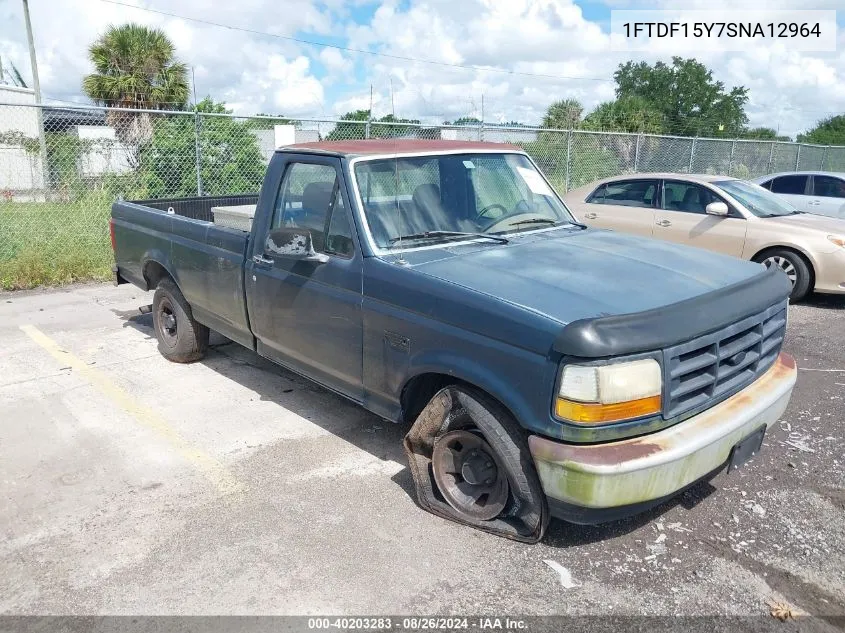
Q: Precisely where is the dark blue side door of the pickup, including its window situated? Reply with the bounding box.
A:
[246,156,363,401]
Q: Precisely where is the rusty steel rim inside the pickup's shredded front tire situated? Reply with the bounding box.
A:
[431,431,510,521]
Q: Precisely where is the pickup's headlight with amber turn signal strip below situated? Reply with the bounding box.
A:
[555,358,663,424]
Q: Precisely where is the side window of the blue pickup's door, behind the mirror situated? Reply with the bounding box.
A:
[271,163,353,257]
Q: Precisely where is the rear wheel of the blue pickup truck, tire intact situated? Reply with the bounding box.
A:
[153,279,209,363]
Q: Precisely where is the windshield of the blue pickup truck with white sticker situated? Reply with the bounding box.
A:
[355,152,573,249]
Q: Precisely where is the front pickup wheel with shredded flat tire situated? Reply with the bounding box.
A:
[405,385,549,543]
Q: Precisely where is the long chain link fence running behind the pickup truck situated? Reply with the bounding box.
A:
[0,104,845,288]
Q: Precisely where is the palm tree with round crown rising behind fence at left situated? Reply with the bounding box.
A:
[82,24,188,143]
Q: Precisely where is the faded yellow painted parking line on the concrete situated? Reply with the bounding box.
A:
[20,325,244,494]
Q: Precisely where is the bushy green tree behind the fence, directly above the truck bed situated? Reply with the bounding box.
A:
[140,97,266,197]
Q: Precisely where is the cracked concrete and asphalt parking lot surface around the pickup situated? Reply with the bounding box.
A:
[0,285,845,617]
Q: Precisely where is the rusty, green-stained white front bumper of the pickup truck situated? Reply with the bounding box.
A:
[528,353,798,523]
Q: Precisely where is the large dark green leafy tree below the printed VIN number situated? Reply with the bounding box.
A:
[613,57,748,137]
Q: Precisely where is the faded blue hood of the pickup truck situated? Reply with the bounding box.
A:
[404,229,764,324]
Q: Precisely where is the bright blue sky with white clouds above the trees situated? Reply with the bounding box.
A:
[0,0,845,136]
